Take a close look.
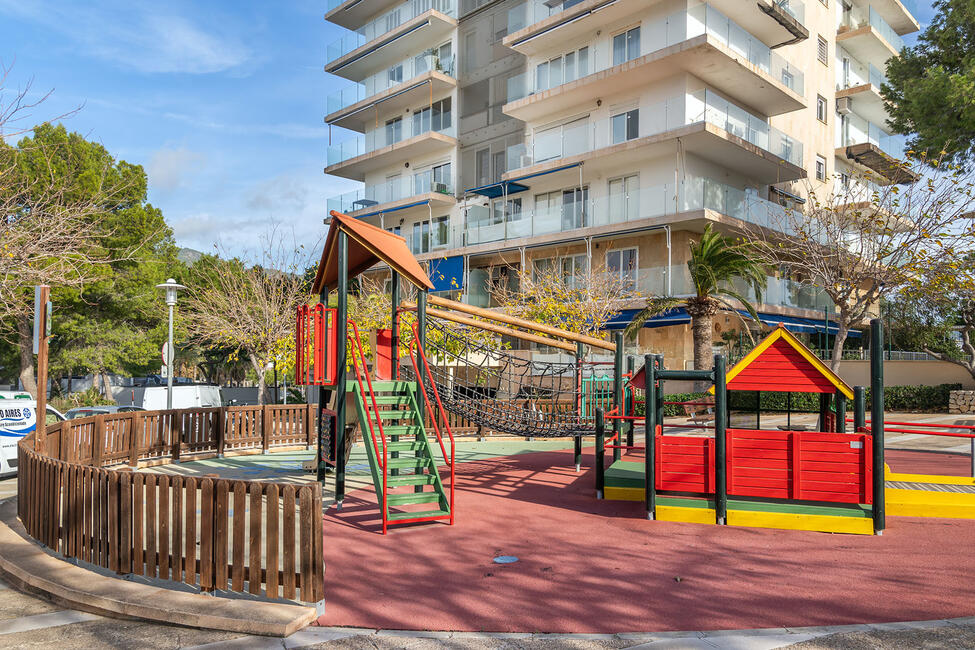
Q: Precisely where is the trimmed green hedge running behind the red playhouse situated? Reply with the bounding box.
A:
[636,384,962,417]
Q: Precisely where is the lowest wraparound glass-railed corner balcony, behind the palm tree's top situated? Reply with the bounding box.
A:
[460,176,789,250]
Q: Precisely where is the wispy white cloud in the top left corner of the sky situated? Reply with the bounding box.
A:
[0,0,252,74]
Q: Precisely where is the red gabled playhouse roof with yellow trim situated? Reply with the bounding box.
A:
[710,325,853,399]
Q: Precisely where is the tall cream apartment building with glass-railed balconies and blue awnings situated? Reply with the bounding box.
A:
[325,0,918,362]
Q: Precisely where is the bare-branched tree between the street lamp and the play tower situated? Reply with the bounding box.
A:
[185,232,310,404]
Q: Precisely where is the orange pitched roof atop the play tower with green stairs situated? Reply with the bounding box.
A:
[312,210,433,293]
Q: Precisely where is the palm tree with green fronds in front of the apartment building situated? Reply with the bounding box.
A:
[625,224,769,370]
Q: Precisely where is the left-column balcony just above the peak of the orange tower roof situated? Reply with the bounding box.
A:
[327,171,457,217]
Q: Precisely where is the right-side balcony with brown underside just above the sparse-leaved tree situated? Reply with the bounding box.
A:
[836,115,918,184]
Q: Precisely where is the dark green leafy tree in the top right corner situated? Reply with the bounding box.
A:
[881,0,975,167]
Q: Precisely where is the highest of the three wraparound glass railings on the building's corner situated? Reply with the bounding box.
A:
[507,3,805,102]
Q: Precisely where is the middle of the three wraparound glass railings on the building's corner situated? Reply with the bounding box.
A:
[507,90,803,171]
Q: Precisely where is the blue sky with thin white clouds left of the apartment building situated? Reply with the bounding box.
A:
[0,0,933,256]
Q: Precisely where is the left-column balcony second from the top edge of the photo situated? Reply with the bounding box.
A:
[325,0,457,81]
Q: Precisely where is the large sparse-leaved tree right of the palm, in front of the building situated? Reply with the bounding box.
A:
[747,156,975,371]
